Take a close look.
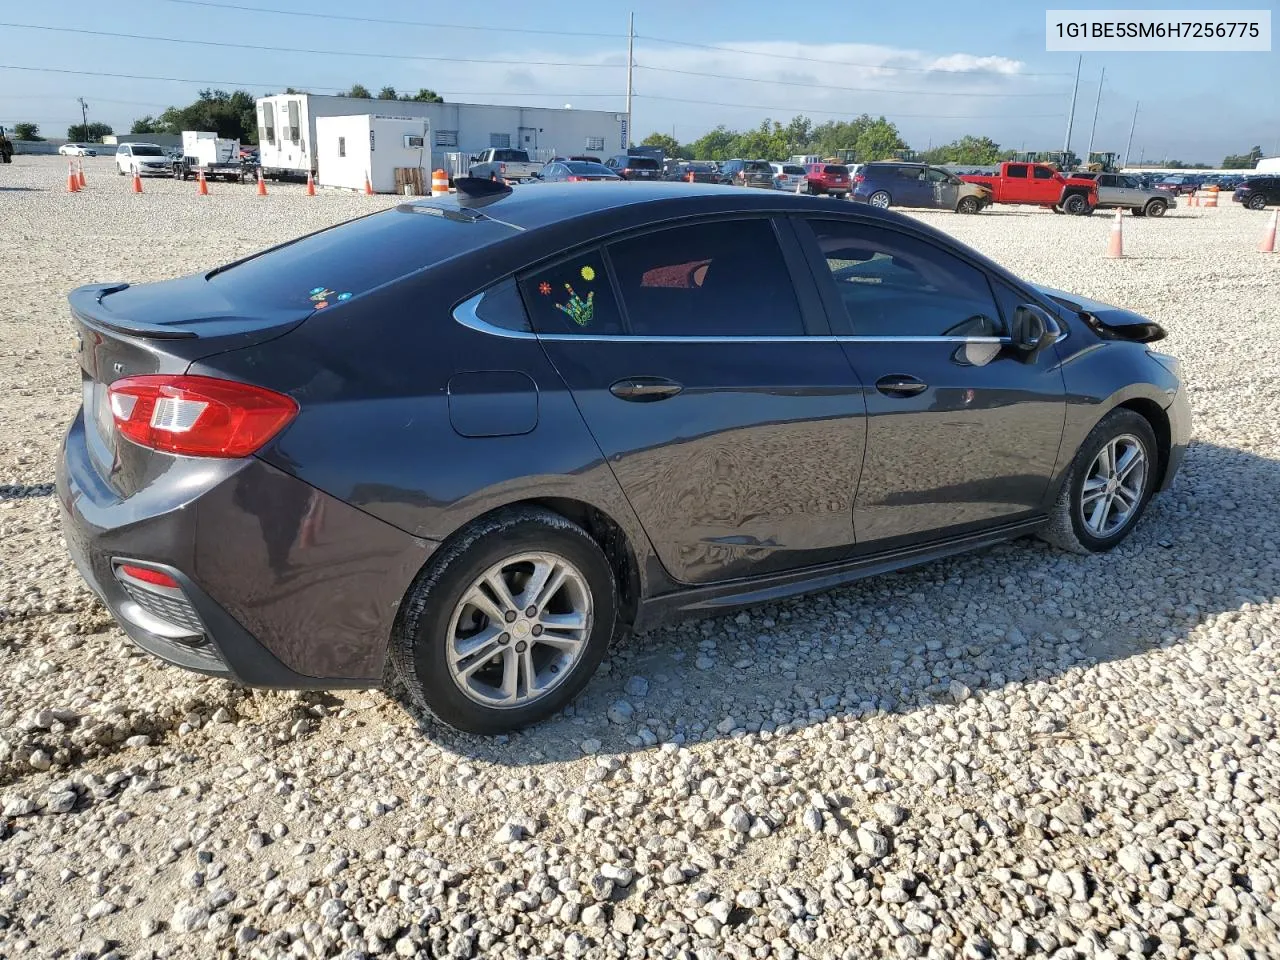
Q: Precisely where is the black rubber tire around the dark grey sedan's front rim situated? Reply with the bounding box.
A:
[1039,407,1160,553]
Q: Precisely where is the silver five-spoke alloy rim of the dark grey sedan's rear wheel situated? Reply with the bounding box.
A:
[447,552,593,709]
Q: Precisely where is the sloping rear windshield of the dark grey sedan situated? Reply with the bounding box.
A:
[209,204,515,310]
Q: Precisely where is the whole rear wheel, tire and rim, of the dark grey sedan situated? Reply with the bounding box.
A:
[392,508,617,733]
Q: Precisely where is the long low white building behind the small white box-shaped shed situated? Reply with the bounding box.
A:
[257,93,626,177]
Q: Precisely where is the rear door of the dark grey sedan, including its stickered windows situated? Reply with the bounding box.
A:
[522,218,865,582]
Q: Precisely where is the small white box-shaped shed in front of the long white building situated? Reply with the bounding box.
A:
[315,114,431,193]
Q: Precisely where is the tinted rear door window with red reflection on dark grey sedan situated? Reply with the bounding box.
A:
[609,219,804,337]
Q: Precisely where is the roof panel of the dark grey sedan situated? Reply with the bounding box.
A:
[413,180,900,238]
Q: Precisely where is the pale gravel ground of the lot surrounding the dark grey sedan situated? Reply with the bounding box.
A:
[0,157,1280,960]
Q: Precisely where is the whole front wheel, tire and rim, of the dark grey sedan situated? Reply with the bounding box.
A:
[1041,408,1160,553]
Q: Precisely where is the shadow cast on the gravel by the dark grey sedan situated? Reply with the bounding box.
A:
[394,443,1280,767]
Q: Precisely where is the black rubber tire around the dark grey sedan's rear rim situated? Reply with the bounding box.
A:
[390,507,617,733]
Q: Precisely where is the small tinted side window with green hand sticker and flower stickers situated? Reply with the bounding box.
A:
[521,250,622,337]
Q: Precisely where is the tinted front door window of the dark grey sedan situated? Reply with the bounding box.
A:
[810,220,1005,337]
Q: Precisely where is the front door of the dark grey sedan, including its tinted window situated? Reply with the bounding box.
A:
[808,219,1065,552]
